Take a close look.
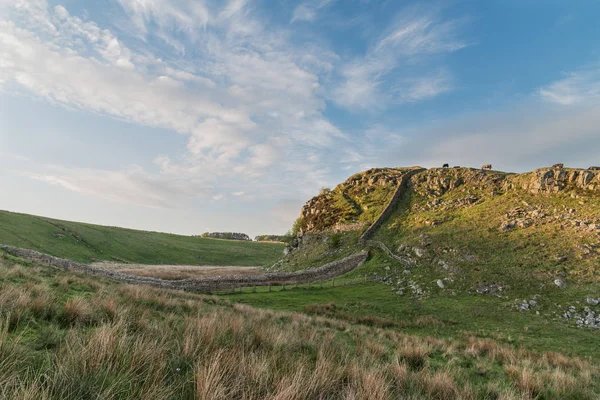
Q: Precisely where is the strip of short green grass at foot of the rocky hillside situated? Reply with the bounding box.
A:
[227,279,600,359]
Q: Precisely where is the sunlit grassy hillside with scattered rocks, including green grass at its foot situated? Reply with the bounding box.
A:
[240,168,600,368]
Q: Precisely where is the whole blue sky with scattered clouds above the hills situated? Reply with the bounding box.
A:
[0,0,600,236]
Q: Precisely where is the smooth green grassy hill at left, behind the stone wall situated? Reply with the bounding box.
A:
[0,211,283,266]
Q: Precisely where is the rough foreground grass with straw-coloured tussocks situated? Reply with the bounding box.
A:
[0,256,600,400]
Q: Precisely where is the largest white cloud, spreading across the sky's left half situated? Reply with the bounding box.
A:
[0,0,343,188]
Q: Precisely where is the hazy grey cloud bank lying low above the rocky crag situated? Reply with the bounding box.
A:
[376,98,600,171]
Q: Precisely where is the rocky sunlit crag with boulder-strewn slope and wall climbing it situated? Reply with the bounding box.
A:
[279,165,600,327]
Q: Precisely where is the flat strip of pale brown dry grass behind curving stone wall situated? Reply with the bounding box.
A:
[92,262,262,280]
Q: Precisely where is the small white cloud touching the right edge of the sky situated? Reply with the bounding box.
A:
[539,66,600,106]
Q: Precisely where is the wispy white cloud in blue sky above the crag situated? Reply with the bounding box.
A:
[333,7,467,109]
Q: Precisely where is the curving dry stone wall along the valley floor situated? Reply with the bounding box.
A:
[0,245,368,292]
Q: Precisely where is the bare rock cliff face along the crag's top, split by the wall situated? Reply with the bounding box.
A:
[300,167,600,232]
